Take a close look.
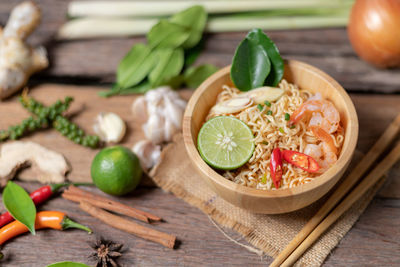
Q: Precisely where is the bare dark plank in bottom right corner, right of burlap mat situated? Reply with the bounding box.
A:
[324,198,400,266]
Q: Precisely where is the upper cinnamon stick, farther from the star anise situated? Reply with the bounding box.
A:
[62,185,162,222]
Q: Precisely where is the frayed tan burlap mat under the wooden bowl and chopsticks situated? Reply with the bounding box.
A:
[151,134,383,266]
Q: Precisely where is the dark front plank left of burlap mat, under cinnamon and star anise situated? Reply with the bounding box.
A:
[3,183,265,267]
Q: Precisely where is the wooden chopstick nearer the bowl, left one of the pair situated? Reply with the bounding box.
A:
[270,114,400,267]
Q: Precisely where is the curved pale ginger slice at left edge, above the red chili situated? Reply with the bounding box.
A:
[0,141,70,186]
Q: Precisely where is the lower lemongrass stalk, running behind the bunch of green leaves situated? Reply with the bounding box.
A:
[58,13,348,39]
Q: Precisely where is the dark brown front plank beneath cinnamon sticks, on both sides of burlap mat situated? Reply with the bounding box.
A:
[3,183,400,267]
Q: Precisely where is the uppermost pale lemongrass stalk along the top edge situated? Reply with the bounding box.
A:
[68,0,354,17]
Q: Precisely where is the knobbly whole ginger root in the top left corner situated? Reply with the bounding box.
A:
[0,1,49,100]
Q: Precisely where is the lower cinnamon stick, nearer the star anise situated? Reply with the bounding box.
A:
[79,201,176,249]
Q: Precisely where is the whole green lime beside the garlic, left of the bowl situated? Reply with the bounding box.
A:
[91,146,142,196]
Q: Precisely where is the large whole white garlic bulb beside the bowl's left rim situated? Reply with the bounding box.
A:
[132,87,186,144]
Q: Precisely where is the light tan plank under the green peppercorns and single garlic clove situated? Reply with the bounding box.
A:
[0,84,191,185]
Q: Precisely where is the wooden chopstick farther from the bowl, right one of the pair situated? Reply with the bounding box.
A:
[281,142,400,266]
